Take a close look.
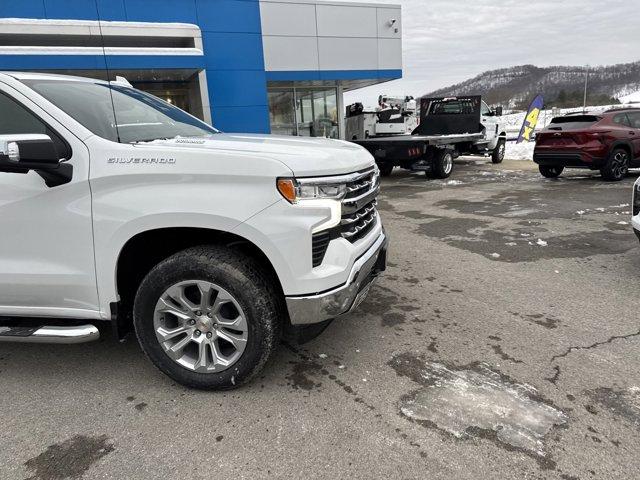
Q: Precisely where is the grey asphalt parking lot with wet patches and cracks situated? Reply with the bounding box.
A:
[0,159,640,480]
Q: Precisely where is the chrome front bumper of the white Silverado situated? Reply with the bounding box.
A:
[286,232,389,325]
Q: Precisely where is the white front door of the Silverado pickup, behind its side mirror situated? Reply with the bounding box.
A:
[0,83,99,319]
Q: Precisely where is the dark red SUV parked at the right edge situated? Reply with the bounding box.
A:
[533,108,640,180]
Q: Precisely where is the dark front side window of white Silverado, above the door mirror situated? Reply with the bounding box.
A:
[0,92,71,159]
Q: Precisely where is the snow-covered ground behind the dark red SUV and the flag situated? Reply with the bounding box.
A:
[502,100,640,160]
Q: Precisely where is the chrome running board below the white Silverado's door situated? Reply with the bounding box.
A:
[0,325,100,344]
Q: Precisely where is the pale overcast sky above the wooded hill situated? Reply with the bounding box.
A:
[345,0,640,106]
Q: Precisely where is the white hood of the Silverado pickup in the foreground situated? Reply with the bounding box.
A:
[139,133,374,177]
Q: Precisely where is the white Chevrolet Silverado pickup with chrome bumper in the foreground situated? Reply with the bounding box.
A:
[0,73,387,389]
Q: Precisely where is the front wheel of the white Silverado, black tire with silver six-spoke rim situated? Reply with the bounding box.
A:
[133,246,282,390]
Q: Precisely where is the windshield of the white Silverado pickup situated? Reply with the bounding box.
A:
[24,80,219,143]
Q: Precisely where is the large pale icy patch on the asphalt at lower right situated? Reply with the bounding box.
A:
[389,354,567,459]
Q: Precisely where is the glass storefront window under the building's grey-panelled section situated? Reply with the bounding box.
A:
[269,88,340,138]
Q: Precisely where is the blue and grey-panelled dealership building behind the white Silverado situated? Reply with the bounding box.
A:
[0,0,402,138]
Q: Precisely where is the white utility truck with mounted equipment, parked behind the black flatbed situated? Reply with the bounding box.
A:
[345,95,418,141]
